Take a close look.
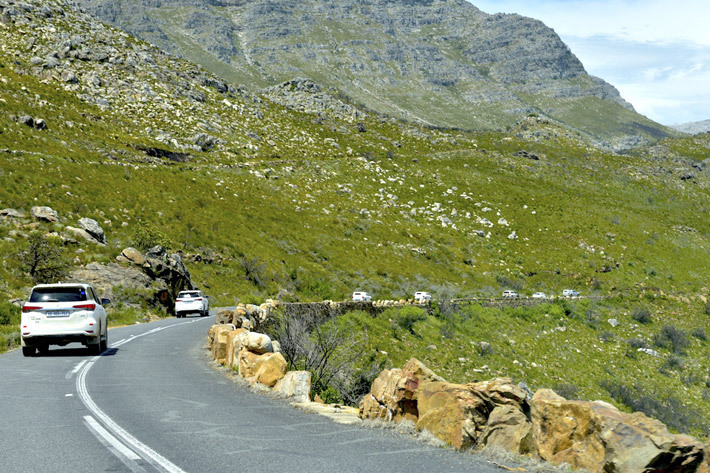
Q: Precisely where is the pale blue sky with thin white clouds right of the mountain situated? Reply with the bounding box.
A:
[470,0,710,125]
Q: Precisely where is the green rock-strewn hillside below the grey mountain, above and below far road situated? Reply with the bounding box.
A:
[0,0,710,434]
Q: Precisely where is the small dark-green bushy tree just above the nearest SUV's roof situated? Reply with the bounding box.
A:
[19,232,70,284]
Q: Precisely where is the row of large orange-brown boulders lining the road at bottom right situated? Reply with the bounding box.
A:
[360,360,709,473]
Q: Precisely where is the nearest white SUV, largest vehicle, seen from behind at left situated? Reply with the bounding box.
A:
[20,284,110,356]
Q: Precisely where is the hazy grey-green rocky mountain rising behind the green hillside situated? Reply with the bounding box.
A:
[68,0,674,149]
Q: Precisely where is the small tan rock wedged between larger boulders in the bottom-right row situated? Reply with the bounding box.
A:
[478,405,536,455]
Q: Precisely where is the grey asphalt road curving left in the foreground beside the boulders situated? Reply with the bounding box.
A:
[0,317,508,473]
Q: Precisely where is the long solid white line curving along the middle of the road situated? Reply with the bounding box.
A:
[76,319,204,473]
